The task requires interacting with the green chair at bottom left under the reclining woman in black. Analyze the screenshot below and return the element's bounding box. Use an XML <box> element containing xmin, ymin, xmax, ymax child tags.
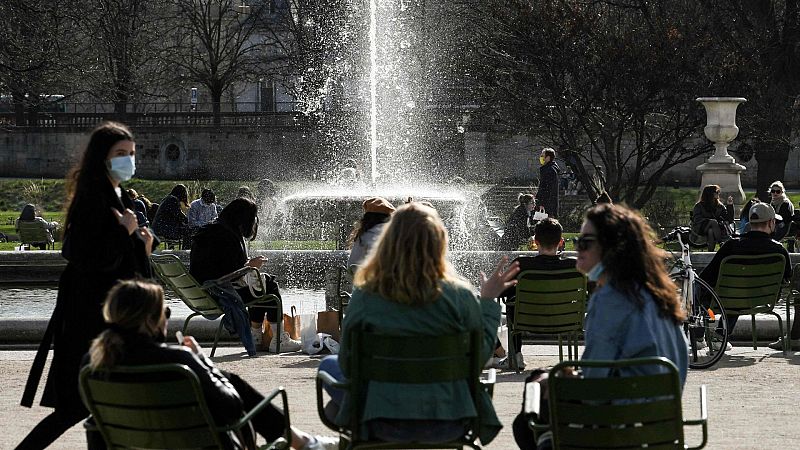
<box><xmin>80</xmin><ymin>364</ymin><xmax>291</xmax><ymax>449</ymax></box>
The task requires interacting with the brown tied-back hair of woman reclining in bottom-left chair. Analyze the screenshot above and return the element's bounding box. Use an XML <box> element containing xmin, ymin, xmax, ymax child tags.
<box><xmin>89</xmin><ymin>280</ymin><xmax>167</xmax><ymax>370</ymax></box>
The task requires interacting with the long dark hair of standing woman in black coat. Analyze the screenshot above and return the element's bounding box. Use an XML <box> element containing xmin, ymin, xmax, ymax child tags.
<box><xmin>64</xmin><ymin>122</ymin><xmax>133</xmax><ymax>230</ymax></box>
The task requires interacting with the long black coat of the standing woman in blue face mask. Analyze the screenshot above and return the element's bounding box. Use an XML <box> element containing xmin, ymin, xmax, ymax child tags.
<box><xmin>22</xmin><ymin>183</ymin><xmax>151</xmax><ymax>414</ymax></box>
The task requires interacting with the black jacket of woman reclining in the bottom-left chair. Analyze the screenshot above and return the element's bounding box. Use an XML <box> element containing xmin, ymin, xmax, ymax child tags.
<box><xmin>82</xmin><ymin>333</ymin><xmax>243</xmax><ymax>425</ymax></box>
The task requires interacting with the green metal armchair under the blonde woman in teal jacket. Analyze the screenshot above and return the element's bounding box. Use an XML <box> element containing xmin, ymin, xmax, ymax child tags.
<box><xmin>317</xmin><ymin>331</ymin><xmax>495</xmax><ymax>450</ymax></box>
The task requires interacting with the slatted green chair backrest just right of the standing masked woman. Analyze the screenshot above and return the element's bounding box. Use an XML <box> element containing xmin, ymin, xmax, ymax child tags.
<box><xmin>150</xmin><ymin>254</ymin><xmax>224</xmax><ymax>316</ymax></box>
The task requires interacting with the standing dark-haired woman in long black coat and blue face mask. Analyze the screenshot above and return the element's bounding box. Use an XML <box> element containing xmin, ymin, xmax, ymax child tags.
<box><xmin>18</xmin><ymin>122</ymin><xmax>153</xmax><ymax>449</ymax></box>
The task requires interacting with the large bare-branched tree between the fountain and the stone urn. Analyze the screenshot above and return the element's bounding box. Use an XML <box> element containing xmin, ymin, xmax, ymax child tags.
<box><xmin>479</xmin><ymin>0</ymin><xmax>728</xmax><ymax>208</ymax></box>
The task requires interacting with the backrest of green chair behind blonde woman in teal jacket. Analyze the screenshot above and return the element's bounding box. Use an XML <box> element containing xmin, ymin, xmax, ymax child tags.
<box><xmin>348</xmin><ymin>330</ymin><xmax>483</xmax><ymax>436</ymax></box>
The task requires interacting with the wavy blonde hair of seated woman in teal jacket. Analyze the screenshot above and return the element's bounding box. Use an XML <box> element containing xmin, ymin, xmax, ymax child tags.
<box><xmin>353</xmin><ymin>202</ymin><xmax>467</xmax><ymax>305</ymax></box>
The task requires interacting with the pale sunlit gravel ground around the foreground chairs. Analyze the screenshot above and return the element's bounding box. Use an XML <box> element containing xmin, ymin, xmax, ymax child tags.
<box><xmin>0</xmin><ymin>345</ymin><xmax>800</xmax><ymax>449</ymax></box>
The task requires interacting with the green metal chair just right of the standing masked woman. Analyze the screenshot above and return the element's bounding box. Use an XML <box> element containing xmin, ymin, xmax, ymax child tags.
<box><xmin>150</xmin><ymin>253</ymin><xmax>283</xmax><ymax>357</ymax></box>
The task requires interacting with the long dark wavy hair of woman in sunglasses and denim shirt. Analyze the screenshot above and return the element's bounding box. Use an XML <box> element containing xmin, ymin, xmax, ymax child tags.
<box><xmin>586</xmin><ymin>203</ymin><xmax>685</xmax><ymax>323</ymax></box>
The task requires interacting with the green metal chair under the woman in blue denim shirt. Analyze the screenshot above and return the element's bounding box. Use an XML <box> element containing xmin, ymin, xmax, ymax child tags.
<box><xmin>524</xmin><ymin>357</ymin><xmax>708</xmax><ymax>449</ymax></box>
